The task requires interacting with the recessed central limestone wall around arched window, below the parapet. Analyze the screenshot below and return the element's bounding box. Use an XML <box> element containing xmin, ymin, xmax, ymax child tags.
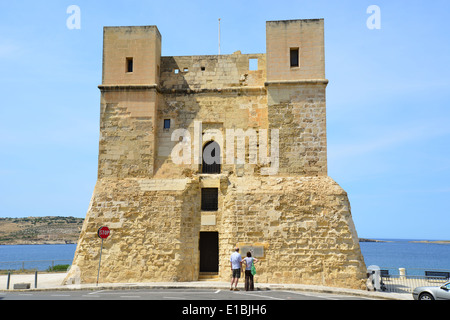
<box><xmin>155</xmin><ymin>89</ymin><xmax>268</xmax><ymax>178</ymax></box>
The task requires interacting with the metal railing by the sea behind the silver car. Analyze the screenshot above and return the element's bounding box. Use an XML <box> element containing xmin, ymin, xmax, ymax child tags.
<box><xmin>380</xmin><ymin>267</ymin><xmax>450</xmax><ymax>293</ymax></box>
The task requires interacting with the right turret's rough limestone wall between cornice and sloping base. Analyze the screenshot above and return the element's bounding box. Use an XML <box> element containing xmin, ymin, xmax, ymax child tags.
<box><xmin>267</xmin><ymin>82</ymin><xmax>327</xmax><ymax>176</ymax></box>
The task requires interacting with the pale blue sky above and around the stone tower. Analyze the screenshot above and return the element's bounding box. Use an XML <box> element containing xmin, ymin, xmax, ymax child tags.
<box><xmin>0</xmin><ymin>0</ymin><xmax>450</xmax><ymax>239</ymax></box>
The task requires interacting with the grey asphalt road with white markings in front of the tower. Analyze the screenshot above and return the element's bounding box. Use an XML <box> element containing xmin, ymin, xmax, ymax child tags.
<box><xmin>0</xmin><ymin>289</ymin><xmax>370</xmax><ymax>301</ymax></box>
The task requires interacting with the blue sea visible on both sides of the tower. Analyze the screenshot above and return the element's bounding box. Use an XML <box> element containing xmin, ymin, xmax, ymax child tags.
<box><xmin>0</xmin><ymin>239</ymin><xmax>450</xmax><ymax>275</ymax></box>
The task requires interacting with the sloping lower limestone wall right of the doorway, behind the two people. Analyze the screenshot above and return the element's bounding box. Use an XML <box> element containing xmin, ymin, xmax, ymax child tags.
<box><xmin>221</xmin><ymin>177</ymin><xmax>365</xmax><ymax>288</ymax></box>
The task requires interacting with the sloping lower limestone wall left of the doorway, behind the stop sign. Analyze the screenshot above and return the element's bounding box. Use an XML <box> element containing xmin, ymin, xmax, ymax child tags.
<box><xmin>68</xmin><ymin>179</ymin><xmax>200</xmax><ymax>283</ymax></box>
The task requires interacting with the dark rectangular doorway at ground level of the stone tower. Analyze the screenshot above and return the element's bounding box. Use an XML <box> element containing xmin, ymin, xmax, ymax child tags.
<box><xmin>199</xmin><ymin>232</ymin><xmax>219</xmax><ymax>272</ymax></box>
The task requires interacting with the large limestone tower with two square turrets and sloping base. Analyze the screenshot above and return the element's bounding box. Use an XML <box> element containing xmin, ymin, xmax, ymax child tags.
<box><xmin>66</xmin><ymin>19</ymin><xmax>365</xmax><ymax>288</ymax></box>
